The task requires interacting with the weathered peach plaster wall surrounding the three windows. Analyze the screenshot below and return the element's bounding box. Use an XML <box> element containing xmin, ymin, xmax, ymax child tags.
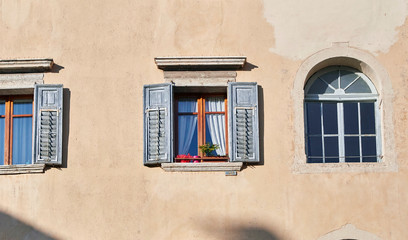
<box><xmin>0</xmin><ymin>0</ymin><xmax>408</xmax><ymax>240</ymax></box>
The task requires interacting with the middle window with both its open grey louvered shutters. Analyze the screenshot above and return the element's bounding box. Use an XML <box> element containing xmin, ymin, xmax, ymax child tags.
<box><xmin>144</xmin><ymin>82</ymin><xmax>259</xmax><ymax>165</ymax></box>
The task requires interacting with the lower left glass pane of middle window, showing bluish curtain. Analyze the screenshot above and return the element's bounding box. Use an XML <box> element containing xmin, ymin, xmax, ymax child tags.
<box><xmin>177</xmin><ymin>115</ymin><xmax>198</xmax><ymax>156</ymax></box>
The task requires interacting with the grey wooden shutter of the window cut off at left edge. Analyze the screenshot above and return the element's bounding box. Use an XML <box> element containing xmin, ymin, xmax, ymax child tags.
<box><xmin>33</xmin><ymin>84</ymin><xmax>63</xmax><ymax>165</ymax></box>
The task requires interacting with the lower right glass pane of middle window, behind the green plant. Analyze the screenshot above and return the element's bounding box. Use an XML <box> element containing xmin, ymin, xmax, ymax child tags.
<box><xmin>205</xmin><ymin>114</ymin><xmax>226</xmax><ymax>156</ymax></box>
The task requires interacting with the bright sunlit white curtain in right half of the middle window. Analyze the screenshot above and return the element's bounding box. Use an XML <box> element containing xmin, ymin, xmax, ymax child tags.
<box><xmin>205</xmin><ymin>97</ymin><xmax>226</xmax><ymax>156</ymax></box>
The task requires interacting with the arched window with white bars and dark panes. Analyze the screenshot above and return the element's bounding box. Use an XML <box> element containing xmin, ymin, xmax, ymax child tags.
<box><xmin>304</xmin><ymin>67</ymin><xmax>381</xmax><ymax>163</ymax></box>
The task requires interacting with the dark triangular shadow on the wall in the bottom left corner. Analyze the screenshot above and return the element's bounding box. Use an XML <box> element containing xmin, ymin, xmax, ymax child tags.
<box><xmin>0</xmin><ymin>212</ymin><xmax>56</xmax><ymax>240</ymax></box>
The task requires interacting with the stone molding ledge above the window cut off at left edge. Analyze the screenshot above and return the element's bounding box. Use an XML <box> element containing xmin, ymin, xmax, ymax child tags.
<box><xmin>0</xmin><ymin>59</ymin><xmax>54</xmax><ymax>73</ymax></box>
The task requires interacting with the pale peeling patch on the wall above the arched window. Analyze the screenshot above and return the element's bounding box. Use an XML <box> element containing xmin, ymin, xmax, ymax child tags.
<box><xmin>263</xmin><ymin>0</ymin><xmax>408</xmax><ymax>59</ymax></box>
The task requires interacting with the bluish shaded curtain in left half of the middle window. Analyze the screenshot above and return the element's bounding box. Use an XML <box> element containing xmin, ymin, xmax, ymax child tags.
<box><xmin>178</xmin><ymin>99</ymin><xmax>197</xmax><ymax>154</ymax></box>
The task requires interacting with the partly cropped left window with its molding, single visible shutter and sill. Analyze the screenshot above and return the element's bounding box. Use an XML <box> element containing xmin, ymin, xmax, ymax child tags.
<box><xmin>0</xmin><ymin>59</ymin><xmax>63</xmax><ymax>174</ymax></box>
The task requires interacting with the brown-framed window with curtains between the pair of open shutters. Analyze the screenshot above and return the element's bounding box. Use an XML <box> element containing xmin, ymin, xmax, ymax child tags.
<box><xmin>175</xmin><ymin>94</ymin><xmax>228</xmax><ymax>162</ymax></box>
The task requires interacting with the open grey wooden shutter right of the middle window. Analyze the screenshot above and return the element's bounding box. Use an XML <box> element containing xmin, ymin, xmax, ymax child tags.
<box><xmin>228</xmin><ymin>82</ymin><xmax>259</xmax><ymax>162</ymax></box>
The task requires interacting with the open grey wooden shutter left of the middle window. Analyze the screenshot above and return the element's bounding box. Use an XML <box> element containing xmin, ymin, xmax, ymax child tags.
<box><xmin>143</xmin><ymin>83</ymin><xmax>173</xmax><ymax>165</ymax></box>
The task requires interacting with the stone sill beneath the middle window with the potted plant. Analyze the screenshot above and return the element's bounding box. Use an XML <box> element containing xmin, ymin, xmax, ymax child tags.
<box><xmin>161</xmin><ymin>162</ymin><xmax>242</xmax><ymax>172</ymax></box>
